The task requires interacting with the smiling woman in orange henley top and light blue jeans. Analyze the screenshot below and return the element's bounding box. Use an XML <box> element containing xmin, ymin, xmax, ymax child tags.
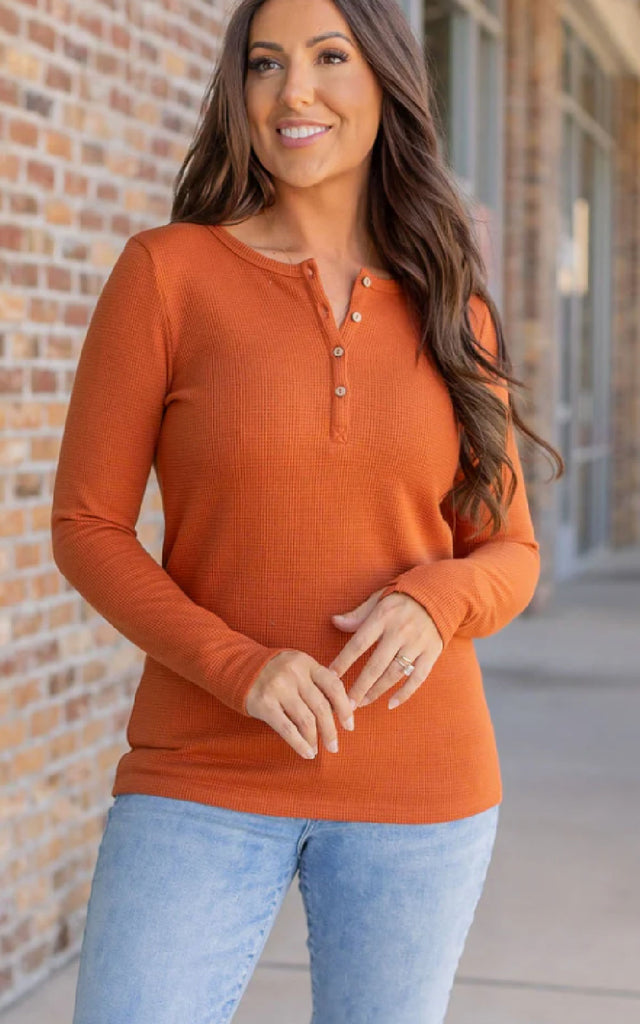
<box><xmin>52</xmin><ymin>0</ymin><xmax>561</xmax><ymax>1024</ymax></box>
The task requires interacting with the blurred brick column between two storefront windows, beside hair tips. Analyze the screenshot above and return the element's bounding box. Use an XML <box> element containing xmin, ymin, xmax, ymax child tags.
<box><xmin>503</xmin><ymin>0</ymin><xmax>561</xmax><ymax>613</ymax></box>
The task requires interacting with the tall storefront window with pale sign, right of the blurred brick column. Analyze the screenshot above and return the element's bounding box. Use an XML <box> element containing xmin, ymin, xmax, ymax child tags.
<box><xmin>557</xmin><ymin>24</ymin><xmax>612</xmax><ymax>574</ymax></box>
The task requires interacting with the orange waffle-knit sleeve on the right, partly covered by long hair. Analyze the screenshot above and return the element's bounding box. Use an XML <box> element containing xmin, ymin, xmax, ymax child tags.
<box><xmin>380</xmin><ymin>303</ymin><xmax>540</xmax><ymax>646</ymax></box>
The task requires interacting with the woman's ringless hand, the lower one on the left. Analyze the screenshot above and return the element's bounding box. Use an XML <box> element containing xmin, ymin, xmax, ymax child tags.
<box><xmin>245</xmin><ymin>650</ymin><xmax>353</xmax><ymax>758</ymax></box>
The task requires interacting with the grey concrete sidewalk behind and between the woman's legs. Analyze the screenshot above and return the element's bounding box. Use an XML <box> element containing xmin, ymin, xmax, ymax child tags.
<box><xmin>0</xmin><ymin>549</ymin><xmax>640</xmax><ymax>1024</ymax></box>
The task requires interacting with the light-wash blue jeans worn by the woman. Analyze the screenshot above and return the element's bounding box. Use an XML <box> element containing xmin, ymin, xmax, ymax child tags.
<box><xmin>73</xmin><ymin>793</ymin><xmax>500</xmax><ymax>1024</ymax></box>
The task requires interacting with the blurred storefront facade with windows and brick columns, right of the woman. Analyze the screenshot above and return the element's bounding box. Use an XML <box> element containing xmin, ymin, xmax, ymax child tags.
<box><xmin>403</xmin><ymin>0</ymin><xmax>640</xmax><ymax>593</ymax></box>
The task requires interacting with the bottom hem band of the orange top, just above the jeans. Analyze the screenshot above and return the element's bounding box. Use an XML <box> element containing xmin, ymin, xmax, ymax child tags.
<box><xmin>112</xmin><ymin>771</ymin><xmax>503</xmax><ymax>824</ymax></box>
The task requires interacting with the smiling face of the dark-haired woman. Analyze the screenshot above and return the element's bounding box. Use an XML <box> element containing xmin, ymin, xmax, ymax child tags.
<box><xmin>245</xmin><ymin>0</ymin><xmax>383</xmax><ymax>187</ymax></box>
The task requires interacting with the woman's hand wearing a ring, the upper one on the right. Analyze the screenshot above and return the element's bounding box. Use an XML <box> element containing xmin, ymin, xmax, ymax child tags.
<box><xmin>329</xmin><ymin>587</ymin><xmax>444</xmax><ymax>707</ymax></box>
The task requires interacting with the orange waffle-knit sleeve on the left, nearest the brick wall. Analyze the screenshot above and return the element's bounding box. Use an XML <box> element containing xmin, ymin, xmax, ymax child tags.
<box><xmin>51</xmin><ymin>238</ymin><xmax>288</xmax><ymax>715</ymax></box>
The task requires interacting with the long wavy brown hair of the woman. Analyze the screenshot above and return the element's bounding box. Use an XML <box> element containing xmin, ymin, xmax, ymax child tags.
<box><xmin>171</xmin><ymin>0</ymin><xmax>564</xmax><ymax>535</ymax></box>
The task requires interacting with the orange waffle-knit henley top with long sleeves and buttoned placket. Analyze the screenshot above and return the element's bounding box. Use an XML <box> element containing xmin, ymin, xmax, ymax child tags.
<box><xmin>51</xmin><ymin>222</ymin><xmax>540</xmax><ymax>823</ymax></box>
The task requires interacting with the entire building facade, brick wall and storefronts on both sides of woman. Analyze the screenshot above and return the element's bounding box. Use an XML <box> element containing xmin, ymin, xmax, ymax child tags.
<box><xmin>0</xmin><ymin>0</ymin><xmax>640</xmax><ymax>1011</ymax></box>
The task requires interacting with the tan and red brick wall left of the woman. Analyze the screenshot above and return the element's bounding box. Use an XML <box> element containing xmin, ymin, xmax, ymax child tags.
<box><xmin>0</xmin><ymin>0</ymin><xmax>225</xmax><ymax>1009</ymax></box>
